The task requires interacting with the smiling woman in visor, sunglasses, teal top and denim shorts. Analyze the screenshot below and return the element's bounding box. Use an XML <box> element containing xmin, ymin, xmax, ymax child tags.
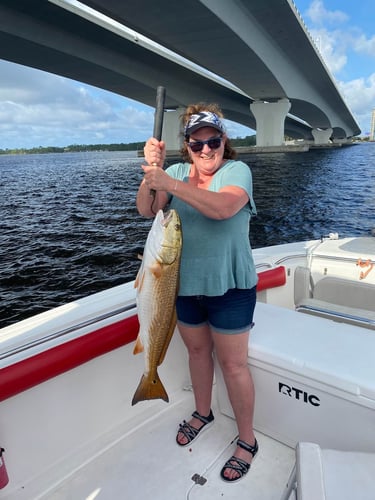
<box><xmin>137</xmin><ymin>104</ymin><xmax>258</xmax><ymax>482</ymax></box>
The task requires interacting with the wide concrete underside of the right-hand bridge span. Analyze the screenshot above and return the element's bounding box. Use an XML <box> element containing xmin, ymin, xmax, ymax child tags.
<box><xmin>85</xmin><ymin>0</ymin><xmax>360</xmax><ymax>138</ymax></box>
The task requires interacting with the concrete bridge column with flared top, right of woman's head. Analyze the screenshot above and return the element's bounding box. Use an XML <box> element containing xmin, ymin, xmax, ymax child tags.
<box><xmin>250</xmin><ymin>99</ymin><xmax>290</xmax><ymax>147</ymax></box>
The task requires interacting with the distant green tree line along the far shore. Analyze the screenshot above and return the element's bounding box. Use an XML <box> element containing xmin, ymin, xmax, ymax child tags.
<box><xmin>0</xmin><ymin>135</ymin><xmax>256</xmax><ymax>155</ymax></box>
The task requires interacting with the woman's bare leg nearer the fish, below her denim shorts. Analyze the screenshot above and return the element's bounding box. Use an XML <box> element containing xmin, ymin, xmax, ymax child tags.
<box><xmin>177</xmin><ymin>324</ymin><xmax>214</xmax><ymax>445</ymax></box>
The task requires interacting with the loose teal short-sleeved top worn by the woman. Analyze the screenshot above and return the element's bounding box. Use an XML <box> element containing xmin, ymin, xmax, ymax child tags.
<box><xmin>166</xmin><ymin>160</ymin><xmax>258</xmax><ymax>296</ymax></box>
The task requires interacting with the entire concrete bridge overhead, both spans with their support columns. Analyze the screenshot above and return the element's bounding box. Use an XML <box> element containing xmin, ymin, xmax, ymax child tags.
<box><xmin>0</xmin><ymin>0</ymin><xmax>360</xmax><ymax>148</ymax></box>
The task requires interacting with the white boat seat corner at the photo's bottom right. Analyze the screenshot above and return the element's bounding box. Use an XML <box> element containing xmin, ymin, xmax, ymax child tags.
<box><xmin>296</xmin><ymin>442</ymin><xmax>375</xmax><ymax>500</ymax></box>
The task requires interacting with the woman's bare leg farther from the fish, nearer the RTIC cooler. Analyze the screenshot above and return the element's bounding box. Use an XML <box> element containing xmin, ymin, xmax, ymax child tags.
<box><xmin>213</xmin><ymin>331</ymin><xmax>255</xmax><ymax>479</ymax></box>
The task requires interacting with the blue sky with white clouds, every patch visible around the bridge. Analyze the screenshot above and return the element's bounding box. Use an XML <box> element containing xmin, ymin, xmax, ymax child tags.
<box><xmin>0</xmin><ymin>0</ymin><xmax>375</xmax><ymax>149</ymax></box>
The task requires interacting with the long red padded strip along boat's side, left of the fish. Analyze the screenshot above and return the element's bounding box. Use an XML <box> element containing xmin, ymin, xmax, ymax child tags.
<box><xmin>0</xmin><ymin>315</ymin><xmax>139</xmax><ymax>401</ymax></box>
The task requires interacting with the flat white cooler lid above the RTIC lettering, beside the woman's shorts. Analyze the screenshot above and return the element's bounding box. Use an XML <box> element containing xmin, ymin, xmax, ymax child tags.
<box><xmin>248</xmin><ymin>302</ymin><xmax>375</xmax><ymax>401</ymax></box>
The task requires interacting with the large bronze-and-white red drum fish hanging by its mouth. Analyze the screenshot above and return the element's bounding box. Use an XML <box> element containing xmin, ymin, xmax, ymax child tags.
<box><xmin>132</xmin><ymin>210</ymin><xmax>182</xmax><ymax>405</ymax></box>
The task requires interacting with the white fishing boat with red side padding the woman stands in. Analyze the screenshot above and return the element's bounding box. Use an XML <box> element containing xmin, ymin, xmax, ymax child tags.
<box><xmin>0</xmin><ymin>238</ymin><xmax>375</xmax><ymax>500</ymax></box>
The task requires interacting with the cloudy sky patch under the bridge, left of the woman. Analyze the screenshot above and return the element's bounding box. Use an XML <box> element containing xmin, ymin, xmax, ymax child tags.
<box><xmin>0</xmin><ymin>61</ymin><xmax>153</xmax><ymax>149</ymax></box>
